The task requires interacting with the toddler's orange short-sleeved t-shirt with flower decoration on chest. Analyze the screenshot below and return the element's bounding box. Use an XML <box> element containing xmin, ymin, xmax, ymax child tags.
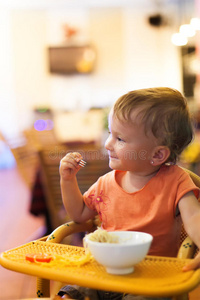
<box><xmin>84</xmin><ymin>165</ymin><xmax>199</xmax><ymax>256</ymax></box>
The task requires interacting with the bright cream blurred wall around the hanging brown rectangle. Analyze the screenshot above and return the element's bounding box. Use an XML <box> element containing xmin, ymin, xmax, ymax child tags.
<box><xmin>0</xmin><ymin>7</ymin><xmax>182</xmax><ymax>137</ymax></box>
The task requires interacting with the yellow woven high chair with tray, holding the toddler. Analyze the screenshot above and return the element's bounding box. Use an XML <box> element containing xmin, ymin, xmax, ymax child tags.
<box><xmin>0</xmin><ymin>170</ymin><xmax>200</xmax><ymax>300</ymax></box>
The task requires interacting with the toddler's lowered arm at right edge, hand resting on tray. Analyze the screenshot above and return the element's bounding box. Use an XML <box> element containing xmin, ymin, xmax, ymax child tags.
<box><xmin>179</xmin><ymin>192</ymin><xmax>200</xmax><ymax>271</ymax></box>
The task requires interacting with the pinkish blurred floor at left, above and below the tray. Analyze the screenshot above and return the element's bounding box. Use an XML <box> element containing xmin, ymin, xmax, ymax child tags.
<box><xmin>0</xmin><ymin>168</ymin><xmax>200</xmax><ymax>300</ymax></box>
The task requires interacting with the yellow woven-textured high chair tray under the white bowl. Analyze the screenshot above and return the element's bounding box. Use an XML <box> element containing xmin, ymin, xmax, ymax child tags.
<box><xmin>0</xmin><ymin>241</ymin><xmax>200</xmax><ymax>296</ymax></box>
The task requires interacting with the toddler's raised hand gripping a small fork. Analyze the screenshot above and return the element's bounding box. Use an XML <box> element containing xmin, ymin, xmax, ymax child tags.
<box><xmin>60</xmin><ymin>152</ymin><xmax>82</xmax><ymax>180</ymax></box>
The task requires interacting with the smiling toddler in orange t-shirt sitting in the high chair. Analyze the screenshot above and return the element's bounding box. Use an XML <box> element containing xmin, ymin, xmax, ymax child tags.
<box><xmin>55</xmin><ymin>87</ymin><xmax>200</xmax><ymax>300</ymax></box>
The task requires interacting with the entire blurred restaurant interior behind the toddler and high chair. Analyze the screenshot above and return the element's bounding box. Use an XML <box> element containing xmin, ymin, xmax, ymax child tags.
<box><xmin>0</xmin><ymin>0</ymin><xmax>200</xmax><ymax>300</ymax></box>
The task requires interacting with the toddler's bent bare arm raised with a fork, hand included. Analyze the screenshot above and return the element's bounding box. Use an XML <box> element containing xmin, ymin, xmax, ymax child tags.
<box><xmin>60</xmin><ymin>152</ymin><xmax>95</xmax><ymax>223</ymax></box>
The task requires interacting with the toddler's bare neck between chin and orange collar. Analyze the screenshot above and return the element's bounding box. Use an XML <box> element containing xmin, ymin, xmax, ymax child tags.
<box><xmin>119</xmin><ymin>169</ymin><xmax>159</xmax><ymax>193</ymax></box>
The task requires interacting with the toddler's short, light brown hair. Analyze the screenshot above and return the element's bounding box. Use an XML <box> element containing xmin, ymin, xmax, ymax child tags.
<box><xmin>113</xmin><ymin>87</ymin><xmax>193</xmax><ymax>163</ymax></box>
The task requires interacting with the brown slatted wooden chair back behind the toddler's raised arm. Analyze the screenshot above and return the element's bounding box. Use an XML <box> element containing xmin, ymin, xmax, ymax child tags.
<box><xmin>39</xmin><ymin>145</ymin><xmax>110</xmax><ymax>229</ymax></box>
